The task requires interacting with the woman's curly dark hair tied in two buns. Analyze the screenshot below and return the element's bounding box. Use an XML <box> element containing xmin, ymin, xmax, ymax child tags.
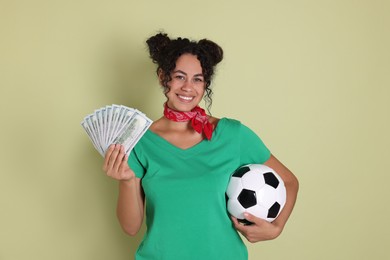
<box><xmin>146</xmin><ymin>32</ymin><xmax>223</xmax><ymax>112</ymax></box>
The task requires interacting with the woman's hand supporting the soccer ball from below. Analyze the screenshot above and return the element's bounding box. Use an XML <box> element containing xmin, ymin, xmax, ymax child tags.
<box><xmin>231</xmin><ymin>213</ymin><xmax>282</xmax><ymax>243</ymax></box>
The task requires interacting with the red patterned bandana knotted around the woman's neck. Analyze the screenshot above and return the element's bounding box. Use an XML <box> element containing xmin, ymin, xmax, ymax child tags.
<box><xmin>164</xmin><ymin>103</ymin><xmax>214</xmax><ymax>140</ymax></box>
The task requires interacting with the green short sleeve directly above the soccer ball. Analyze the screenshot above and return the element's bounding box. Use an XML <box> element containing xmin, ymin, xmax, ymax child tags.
<box><xmin>239</xmin><ymin>124</ymin><xmax>271</xmax><ymax>165</ymax></box>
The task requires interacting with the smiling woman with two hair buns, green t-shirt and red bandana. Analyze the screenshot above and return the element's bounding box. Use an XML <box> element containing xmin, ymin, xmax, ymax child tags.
<box><xmin>103</xmin><ymin>33</ymin><xmax>298</xmax><ymax>260</ymax></box>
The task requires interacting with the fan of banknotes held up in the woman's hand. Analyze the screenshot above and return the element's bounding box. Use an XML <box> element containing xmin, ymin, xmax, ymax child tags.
<box><xmin>81</xmin><ymin>104</ymin><xmax>152</xmax><ymax>157</ymax></box>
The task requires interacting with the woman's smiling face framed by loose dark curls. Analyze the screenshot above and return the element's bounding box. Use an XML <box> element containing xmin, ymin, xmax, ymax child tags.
<box><xmin>162</xmin><ymin>54</ymin><xmax>205</xmax><ymax>111</ymax></box>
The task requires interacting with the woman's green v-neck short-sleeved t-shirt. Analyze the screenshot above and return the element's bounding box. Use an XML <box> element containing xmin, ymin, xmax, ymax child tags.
<box><xmin>129</xmin><ymin>118</ymin><xmax>270</xmax><ymax>260</ymax></box>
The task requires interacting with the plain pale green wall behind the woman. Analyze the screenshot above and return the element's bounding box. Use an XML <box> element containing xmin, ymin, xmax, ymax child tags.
<box><xmin>0</xmin><ymin>0</ymin><xmax>390</xmax><ymax>260</ymax></box>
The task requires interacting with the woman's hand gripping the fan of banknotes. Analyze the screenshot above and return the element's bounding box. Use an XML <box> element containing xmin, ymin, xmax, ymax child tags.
<box><xmin>103</xmin><ymin>144</ymin><xmax>135</xmax><ymax>181</ymax></box>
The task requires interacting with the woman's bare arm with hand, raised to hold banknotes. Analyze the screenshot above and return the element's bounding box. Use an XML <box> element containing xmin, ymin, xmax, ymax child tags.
<box><xmin>103</xmin><ymin>145</ymin><xmax>144</xmax><ymax>236</ymax></box>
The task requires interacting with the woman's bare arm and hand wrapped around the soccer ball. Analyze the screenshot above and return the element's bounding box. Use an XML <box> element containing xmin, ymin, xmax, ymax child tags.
<box><xmin>232</xmin><ymin>155</ymin><xmax>299</xmax><ymax>243</ymax></box>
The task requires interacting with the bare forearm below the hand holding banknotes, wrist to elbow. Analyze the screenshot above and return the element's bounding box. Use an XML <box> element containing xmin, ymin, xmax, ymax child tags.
<box><xmin>117</xmin><ymin>177</ymin><xmax>144</xmax><ymax>236</ymax></box>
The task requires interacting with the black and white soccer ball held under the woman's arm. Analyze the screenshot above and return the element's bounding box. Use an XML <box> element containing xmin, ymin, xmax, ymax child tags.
<box><xmin>226</xmin><ymin>164</ymin><xmax>286</xmax><ymax>225</ymax></box>
